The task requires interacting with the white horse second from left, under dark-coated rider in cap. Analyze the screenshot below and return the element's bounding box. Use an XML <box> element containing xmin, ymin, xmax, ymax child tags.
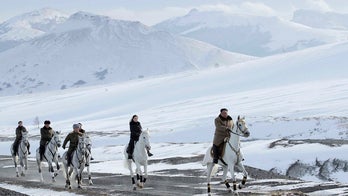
<box><xmin>36</xmin><ymin>131</ymin><xmax>62</xmax><ymax>182</ymax></box>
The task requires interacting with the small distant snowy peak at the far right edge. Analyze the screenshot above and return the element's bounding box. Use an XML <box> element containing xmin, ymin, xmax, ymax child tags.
<box><xmin>292</xmin><ymin>10</ymin><xmax>348</xmax><ymax>30</ymax></box>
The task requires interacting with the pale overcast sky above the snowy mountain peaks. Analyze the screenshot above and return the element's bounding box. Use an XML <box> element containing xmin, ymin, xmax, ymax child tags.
<box><xmin>0</xmin><ymin>0</ymin><xmax>348</xmax><ymax>25</ymax></box>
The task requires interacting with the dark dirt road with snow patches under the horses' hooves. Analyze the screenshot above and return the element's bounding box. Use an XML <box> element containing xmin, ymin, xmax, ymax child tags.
<box><xmin>0</xmin><ymin>156</ymin><xmax>348</xmax><ymax>196</ymax></box>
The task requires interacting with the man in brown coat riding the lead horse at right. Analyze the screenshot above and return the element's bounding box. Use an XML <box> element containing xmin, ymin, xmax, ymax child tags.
<box><xmin>213</xmin><ymin>108</ymin><xmax>233</xmax><ymax>164</ymax></box>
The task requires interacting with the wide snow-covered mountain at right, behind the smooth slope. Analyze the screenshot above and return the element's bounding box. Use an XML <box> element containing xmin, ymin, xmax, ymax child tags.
<box><xmin>154</xmin><ymin>9</ymin><xmax>348</xmax><ymax>56</ymax></box>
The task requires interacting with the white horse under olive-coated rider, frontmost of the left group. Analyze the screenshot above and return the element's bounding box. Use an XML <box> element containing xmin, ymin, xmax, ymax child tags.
<box><xmin>63</xmin><ymin>135</ymin><xmax>86</xmax><ymax>189</ymax></box>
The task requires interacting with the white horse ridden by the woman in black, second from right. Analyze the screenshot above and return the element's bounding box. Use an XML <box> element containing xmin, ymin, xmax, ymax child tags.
<box><xmin>124</xmin><ymin>130</ymin><xmax>151</xmax><ymax>190</ymax></box>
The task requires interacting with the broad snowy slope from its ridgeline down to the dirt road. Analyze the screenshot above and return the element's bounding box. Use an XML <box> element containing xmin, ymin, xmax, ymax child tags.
<box><xmin>0</xmin><ymin>42</ymin><xmax>348</xmax><ymax>185</ymax></box>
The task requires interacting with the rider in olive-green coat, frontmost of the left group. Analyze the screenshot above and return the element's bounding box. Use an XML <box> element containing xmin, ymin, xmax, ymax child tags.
<box><xmin>63</xmin><ymin>124</ymin><xmax>83</xmax><ymax>166</ymax></box>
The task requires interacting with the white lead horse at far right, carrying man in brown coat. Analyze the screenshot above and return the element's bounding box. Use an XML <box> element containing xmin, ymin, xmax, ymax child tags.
<box><xmin>203</xmin><ymin>116</ymin><xmax>250</xmax><ymax>195</ymax></box>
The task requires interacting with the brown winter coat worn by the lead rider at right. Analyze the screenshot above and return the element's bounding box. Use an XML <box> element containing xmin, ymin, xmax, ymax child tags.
<box><xmin>213</xmin><ymin>115</ymin><xmax>233</xmax><ymax>146</ymax></box>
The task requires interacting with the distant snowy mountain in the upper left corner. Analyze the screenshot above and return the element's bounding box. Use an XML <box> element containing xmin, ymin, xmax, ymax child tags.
<box><xmin>0</xmin><ymin>8</ymin><xmax>68</xmax><ymax>52</ymax></box>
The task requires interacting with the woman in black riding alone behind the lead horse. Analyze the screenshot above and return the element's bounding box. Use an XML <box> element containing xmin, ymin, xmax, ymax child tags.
<box><xmin>127</xmin><ymin>115</ymin><xmax>153</xmax><ymax>159</ymax></box>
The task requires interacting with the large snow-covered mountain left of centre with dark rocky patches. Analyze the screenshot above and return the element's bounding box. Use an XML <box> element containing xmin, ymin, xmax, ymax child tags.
<box><xmin>0</xmin><ymin>12</ymin><xmax>254</xmax><ymax>95</ymax></box>
